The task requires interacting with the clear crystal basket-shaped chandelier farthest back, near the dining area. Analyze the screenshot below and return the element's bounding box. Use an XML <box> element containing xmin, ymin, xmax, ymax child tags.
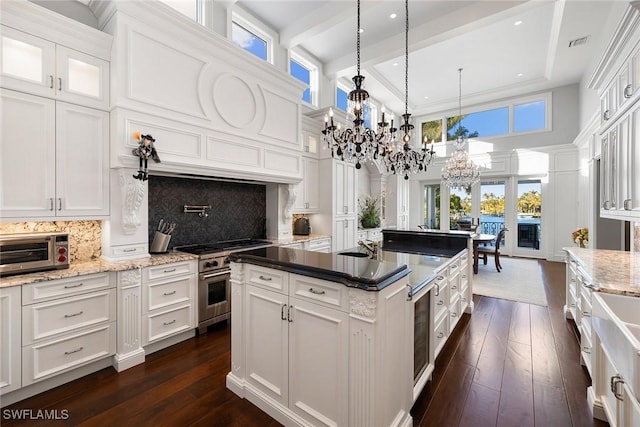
<box><xmin>442</xmin><ymin>68</ymin><xmax>480</xmax><ymax>188</ymax></box>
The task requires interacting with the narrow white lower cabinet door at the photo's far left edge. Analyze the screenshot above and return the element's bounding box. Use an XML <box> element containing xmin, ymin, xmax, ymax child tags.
<box><xmin>0</xmin><ymin>286</ymin><xmax>22</xmax><ymax>395</ymax></box>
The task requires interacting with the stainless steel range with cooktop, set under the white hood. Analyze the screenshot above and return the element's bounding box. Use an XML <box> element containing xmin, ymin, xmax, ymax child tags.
<box><xmin>174</xmin><ymin>239</ymin><xmax>272</xmax><ymax>334</ymax></box>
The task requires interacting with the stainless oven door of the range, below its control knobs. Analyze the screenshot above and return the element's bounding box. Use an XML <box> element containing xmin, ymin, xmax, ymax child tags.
<box><xmin>198</xmin><ymin>269</ymin><xmax>231</xmax><ymax>332</ymax></box>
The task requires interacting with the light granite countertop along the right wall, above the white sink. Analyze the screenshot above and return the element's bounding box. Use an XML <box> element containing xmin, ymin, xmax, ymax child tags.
<box><xmin>563</xmin><ymin>247</ymin><xmax>640</xmax><ymax>297</ymax></box>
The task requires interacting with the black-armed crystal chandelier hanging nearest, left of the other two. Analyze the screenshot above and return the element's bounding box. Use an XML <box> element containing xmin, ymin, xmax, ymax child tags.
<box><xmin>322</xmin><ymin>0</ymin><xmax>396</xmax><ymax>169</ymax></box>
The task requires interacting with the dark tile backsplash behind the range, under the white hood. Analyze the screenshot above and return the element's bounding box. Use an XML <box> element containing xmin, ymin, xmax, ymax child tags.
<box><xmin>149</xmin><ymin>176</ymin><xmax>266</xmax><ymax>248</ymax></box>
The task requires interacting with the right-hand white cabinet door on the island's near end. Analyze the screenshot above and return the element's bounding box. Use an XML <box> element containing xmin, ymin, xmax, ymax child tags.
<box><xmin>289</xmin><ymin>298</ymin><xmax>349</xmax><ymax>426</ymax></box>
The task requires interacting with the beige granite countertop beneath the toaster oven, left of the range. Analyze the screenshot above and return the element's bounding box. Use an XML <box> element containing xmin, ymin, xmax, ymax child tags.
<box><xmin>0</xmin><ymin>252</ymin><xmax>198</xmax><ymax>288</ymax></box>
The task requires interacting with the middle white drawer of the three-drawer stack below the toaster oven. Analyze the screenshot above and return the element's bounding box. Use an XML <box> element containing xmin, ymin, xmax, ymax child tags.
<box><xmin>22</xmin><ymin>289</ymin><xmax>116</xmax><ymax>345</ymax></box>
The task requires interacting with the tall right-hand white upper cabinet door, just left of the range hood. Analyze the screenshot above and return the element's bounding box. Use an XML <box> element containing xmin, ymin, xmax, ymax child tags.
<box><xmin>56</xmin><ymin>102</ymin><xmax>109</xmax><ymax>216</ymax></box>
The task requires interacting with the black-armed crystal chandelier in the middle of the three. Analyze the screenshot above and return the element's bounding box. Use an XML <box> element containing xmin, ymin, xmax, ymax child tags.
<box><xmin>381</xmin><ymin>0</ymin><xmax>434</xmax><ymax>179</ymax></box>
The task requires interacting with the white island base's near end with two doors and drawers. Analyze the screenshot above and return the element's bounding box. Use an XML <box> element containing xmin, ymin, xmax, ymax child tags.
<box><xmin>227</xmin><ymin>262</ymin><xmax>413</xmax><ymax>426</ymax></box>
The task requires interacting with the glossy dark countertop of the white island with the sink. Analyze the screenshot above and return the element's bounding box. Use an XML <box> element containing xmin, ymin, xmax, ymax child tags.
<box><xmin>229</xmin><ymin>247</ymin><xmax>456</xmax><ymax>293</ymax></box>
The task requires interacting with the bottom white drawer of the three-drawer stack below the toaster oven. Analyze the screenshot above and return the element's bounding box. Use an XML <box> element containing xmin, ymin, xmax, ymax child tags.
<box><xmin>22</xmin><ymin>323</ymin><xmax>116</xmax><ymax>386</ymax></box>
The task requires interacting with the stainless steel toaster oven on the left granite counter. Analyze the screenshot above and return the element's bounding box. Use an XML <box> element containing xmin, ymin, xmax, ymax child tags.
<box><xmin>0</xmin><ymin>233</ymin><xmax>69</xmax><ymax>276</ymax></box>
